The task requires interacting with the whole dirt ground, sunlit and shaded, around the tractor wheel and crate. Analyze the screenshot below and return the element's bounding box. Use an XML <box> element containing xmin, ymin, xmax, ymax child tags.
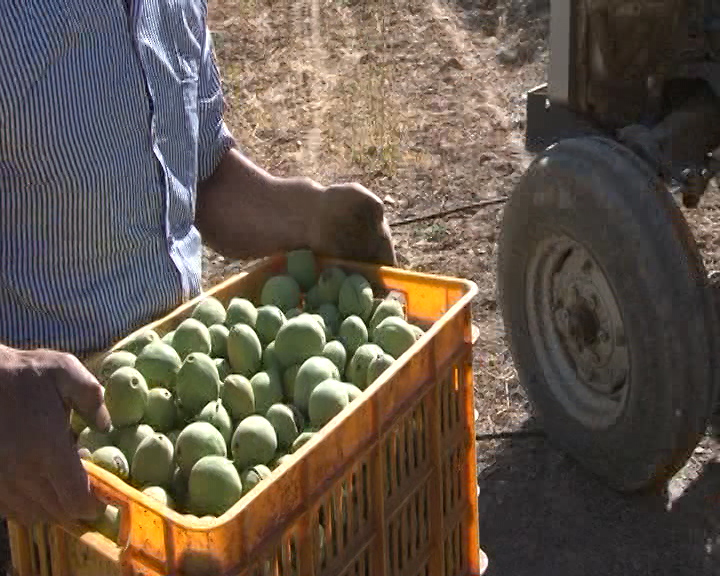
<box><xmin>205</xmin><ymin>0</ymin><xmax>720</xmax><ymax>576</ymax></box>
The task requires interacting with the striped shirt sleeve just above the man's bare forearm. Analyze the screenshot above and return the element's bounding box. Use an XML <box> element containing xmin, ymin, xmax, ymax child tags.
<box><xmin>198</xmin><ymin>27</ymin><xmax>235</xmax><ymax>182</ymax></box>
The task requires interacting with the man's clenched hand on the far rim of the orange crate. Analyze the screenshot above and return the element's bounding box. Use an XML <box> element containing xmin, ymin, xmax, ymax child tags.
<box><xmin>308</xmin><ymin>183</ymin><xmax>397</xmax><ymax>266</ymax></box>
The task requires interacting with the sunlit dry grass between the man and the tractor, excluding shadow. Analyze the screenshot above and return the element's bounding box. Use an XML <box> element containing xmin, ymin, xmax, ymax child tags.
<box><xmin>200</xmin><ymin>0</ymin><xmax>544</xmax><ymax>432</ymax></box>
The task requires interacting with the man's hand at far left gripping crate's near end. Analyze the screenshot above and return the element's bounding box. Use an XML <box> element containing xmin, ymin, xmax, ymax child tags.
<box><xmin>0</xmin><ymin>346</ymin><xmax>110</xmax><ymax>524</ymax></box>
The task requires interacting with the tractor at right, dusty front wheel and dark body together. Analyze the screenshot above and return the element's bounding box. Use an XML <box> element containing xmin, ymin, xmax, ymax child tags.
<box><xmin>497</xmin><ymin>0</ymin><xmax>720</xmax><ymax>493</ymax></box>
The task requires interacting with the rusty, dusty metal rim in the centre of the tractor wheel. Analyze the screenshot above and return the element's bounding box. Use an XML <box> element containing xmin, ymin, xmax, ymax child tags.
<box><xmin>526</xmin><ymin>237</ymin><xmax>630</xmax><ymax>428</ymax></box>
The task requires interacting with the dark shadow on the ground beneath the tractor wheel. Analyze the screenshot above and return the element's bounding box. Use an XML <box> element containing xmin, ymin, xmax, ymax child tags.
<box><xmin>478</xmin><ymin>418</ymin><xmax>720</xmax><ymax>576</ymax></box>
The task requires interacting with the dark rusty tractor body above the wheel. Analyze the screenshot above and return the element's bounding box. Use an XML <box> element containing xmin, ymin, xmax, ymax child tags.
<box><xmin>526</xmin><ymin>0</ymin><xmax>720</xmax><ymax>206</ymax></box>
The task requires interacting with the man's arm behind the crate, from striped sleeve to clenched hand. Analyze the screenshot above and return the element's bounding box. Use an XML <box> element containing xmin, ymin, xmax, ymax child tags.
<box><xmin>195</xmin><ymin>31</ymin><xmax>396</xmax><ymax>265</ymax></box>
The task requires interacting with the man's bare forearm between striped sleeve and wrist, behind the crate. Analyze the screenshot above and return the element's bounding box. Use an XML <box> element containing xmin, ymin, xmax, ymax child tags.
<box><xmin>195</xmin><ymin>149</ymin><xmax>322</xmax><ymax>259</ymax></box>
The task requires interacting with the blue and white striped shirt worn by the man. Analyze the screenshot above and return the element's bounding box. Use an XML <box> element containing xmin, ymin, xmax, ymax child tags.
<box><xmin>0</xmin><ymin>0</ymin><xmax>234</xmax><ymax>355</ymax></box>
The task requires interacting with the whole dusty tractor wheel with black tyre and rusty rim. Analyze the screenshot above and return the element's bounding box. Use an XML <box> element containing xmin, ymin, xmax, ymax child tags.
<box><xmin>498</xmin><ymin>137</ymin><xmax>716</xmax><ymax>492</ymax></box>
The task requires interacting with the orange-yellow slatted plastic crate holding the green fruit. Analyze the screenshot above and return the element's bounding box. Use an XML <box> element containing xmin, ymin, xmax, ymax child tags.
<box><xmin>9</xmin><ymin>256</ymin><xmax>487</xmax><ymax>576</ymax></box>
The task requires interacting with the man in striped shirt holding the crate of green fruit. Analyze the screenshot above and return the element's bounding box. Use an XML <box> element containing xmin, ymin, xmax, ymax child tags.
<box><xmin>0</xmin><ymin>0</ymin><xmax>395</xmax><ymax>544</ymax></box>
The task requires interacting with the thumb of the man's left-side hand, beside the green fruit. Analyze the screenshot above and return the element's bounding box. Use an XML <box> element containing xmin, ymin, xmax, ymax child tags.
<box><xmin>57</xmin><ymin>355</ymin><xmax>111</xmax><ymax>432</ymax></box>
